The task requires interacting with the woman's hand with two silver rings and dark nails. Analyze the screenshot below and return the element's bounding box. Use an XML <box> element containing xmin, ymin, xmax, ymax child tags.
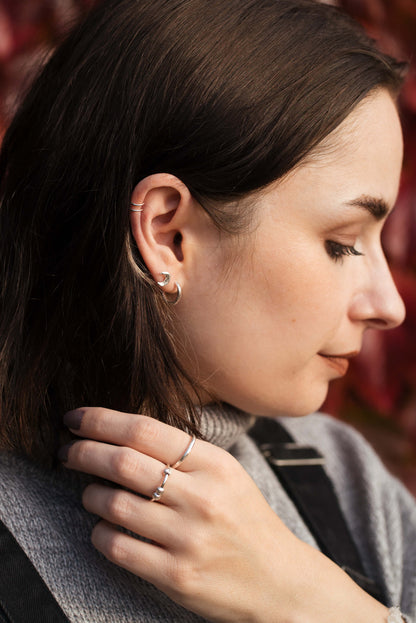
<box><xmin>60</xmin><ymin>408</ymin><xmax>387</xmax><ymax>623</ymax></box>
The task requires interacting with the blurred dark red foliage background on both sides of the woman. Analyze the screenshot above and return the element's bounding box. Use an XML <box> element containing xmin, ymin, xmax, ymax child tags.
<box><xmin>0</xmin><ymin>0</ymin><xmax>416</xmax><ymax>493</ymax></box>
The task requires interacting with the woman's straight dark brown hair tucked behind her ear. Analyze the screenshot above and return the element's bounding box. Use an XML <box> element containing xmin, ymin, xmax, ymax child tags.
<box><xmin>0</xmin><ymin>0</ymin><xmax>402</xmax><ymax>460</ymax></box>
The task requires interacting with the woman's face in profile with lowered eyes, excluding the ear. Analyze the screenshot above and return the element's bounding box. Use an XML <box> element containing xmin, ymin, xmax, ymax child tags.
<box><xmin>177</xmin><ymin>91</ymin><xmax>405</xmax><ymax>415</ymax></box>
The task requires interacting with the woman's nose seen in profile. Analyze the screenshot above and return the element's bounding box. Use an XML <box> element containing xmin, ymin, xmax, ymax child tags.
<box><xmin>350</xmin><ymin>256</ymin><xmax>406</xmax><ymax>330</ymax></box>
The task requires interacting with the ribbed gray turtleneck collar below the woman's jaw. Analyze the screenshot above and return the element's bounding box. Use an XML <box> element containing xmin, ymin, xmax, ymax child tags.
<box><xmin>200</xmin><ymin>403</ymin><xmax>255</xmax><ymax>450</ymax></box>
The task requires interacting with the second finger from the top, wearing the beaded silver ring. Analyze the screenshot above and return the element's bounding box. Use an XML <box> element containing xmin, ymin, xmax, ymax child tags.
<box><xmin>61</xmin><ymin>439</ymin><xmax>188</xmax><ymax>506</ymax></box>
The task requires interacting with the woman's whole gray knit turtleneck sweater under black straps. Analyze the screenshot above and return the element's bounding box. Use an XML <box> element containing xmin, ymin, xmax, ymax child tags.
<box><xmin>0</xmin><ymin>407</ymin><xmax>416</xmax><ymax>623</ymax></box>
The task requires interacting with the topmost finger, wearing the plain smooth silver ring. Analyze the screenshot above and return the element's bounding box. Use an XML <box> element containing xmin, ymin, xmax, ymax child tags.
<box><xmin>64</xmin><ymin>407</ymin><xmax>206</xmax><ymax>471</ymax></box>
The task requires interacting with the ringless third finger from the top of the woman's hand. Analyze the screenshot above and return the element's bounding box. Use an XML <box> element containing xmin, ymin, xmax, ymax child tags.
<box><xmin>82</xmin><ymin>484</ymin><xmax>180</xmax><ymax>547</ymax></box>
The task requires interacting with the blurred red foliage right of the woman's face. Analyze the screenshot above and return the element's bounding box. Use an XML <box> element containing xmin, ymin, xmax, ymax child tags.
<box><xmin>325</xmin><ymin>0</ymin><xmax>416</xmax><ymax>494</ymax></box>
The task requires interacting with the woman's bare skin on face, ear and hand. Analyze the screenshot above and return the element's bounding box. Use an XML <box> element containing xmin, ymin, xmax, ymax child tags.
<box><xmin>62</xmin><ymin>91</ymin><xmax>404</xmax><ymax>623</ymax></box>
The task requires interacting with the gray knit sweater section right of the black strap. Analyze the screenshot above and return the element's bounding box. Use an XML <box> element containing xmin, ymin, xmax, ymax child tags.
<box><xmin>283</xmin><ymin>414</ymin><xmax>416</xmax><ymax>623</ymax></box>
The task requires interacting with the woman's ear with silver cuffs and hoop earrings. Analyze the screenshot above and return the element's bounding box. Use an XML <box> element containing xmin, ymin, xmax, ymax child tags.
<box><xmin>130</xmin><ymin>173</ymin><xmax>210</xmax><ymax>300</ymax></box>
